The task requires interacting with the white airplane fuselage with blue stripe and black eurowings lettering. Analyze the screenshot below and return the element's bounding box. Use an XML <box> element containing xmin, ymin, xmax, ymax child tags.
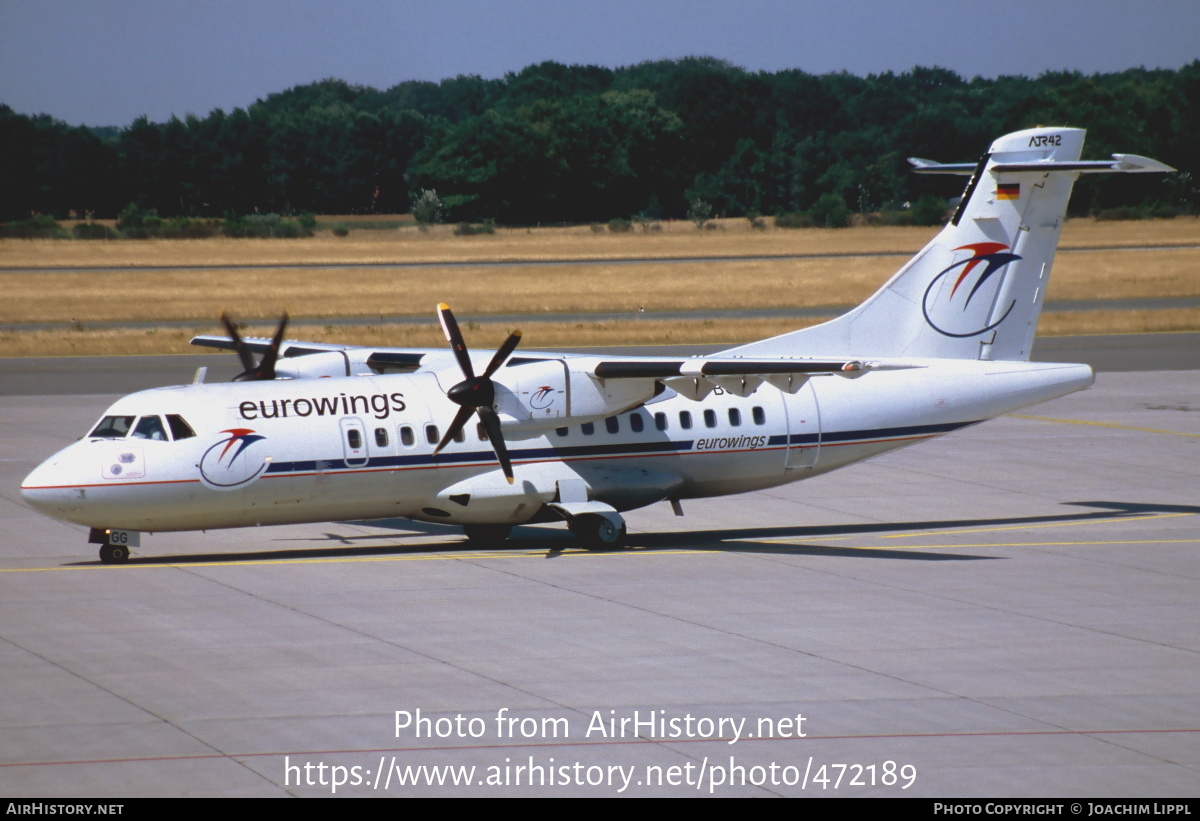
<box><xmin>22</xmin><ymin>360</ymin><xmax>1092</xmax><ymax>531</ymax></box>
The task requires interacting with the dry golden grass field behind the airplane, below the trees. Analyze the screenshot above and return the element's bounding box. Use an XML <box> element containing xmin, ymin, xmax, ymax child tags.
<box><xmin>0</xmin><ymin>218</ymin><xmax>1200</xmax><ymax>355</ymax></box>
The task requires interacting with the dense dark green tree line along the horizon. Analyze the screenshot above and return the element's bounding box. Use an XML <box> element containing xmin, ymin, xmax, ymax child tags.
<box><xmin>0</xmin><ymin>58</ymin><xmax>1200</xmax><ymax>224</ymax></box>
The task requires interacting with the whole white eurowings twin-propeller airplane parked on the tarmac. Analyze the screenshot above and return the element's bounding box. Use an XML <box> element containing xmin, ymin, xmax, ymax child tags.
<box><xmin>22</xmin><ymin>127</ymin><xmax>1172</xmax><ymax>563</ymax></box>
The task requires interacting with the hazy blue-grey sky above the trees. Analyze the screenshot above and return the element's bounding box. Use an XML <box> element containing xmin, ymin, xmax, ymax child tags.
<box><xmin>0</xmin><ymin>0</ymin><xmax>1200</xmax><ymax>125</ymax></box>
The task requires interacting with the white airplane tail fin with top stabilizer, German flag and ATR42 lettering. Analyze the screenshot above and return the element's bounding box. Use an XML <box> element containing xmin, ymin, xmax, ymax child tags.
<box><xmin>722</xmin><ymin>127</ymin><xmax>1174</xmax><ymax>360</ymax></box>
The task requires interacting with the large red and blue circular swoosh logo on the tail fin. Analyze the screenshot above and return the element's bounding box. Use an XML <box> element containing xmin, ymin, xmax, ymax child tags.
<box><xmin>922</xmin><ymin>242</ymin><xmax>1021</xmax><ymax>338</ymax></box>
